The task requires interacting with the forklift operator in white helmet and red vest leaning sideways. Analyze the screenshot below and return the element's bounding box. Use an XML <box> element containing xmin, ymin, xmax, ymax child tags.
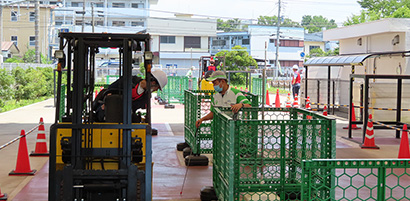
<box><xmin>94</xmin><ymin>70</ymin><xmax>168</xmax><ymax>122</ymax></box>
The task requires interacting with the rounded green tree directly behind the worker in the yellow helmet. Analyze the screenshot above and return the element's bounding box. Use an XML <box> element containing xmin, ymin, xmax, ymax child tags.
<box><xmin>215</xmin><ymin>45</ymin><xmax>258</xmax><ymax>84</ymax></box>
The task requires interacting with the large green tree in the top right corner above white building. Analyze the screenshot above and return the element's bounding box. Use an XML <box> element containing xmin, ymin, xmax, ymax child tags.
<box><xmin>343</xmin><ymin>0</ymin><xmax>410</xmax><ymax>26</ymax></box>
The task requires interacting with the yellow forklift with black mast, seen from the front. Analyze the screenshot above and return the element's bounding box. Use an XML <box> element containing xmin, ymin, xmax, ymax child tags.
<box><xmin>48</xmin><ymin>33</ymin><xmax>152</xmax><ymax>201</ymax></box>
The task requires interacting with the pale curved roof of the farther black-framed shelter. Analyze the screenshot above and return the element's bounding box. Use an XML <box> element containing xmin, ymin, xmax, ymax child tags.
<box><xmin>303</xmin><ymin>54</ymin><xmax>372</xmax><ymax>66</ymax></box>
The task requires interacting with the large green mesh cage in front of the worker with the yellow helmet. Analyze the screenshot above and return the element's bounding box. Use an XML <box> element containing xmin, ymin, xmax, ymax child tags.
<box><xmin>212</xmin><ymin>108</ymin><xmax>336</xmax><ymax>201</ymax></box>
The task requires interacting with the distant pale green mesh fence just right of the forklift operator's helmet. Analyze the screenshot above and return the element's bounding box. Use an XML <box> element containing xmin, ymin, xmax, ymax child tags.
<box><xmin>158</xmin><ymin>76</ymin><xmax>197</xmax><ymax>103</ymax></box>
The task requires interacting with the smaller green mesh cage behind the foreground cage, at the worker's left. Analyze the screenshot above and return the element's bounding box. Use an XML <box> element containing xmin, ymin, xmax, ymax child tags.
<box><xmin>184</xmin><ymin>90</ymin><xmax>258</xmax><ymax>154</ymax></box>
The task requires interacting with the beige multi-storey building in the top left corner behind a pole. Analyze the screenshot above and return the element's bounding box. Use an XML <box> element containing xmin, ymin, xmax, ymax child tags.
<box><xmin>1</xmin><ymin>4</ymin><xmax>53</xmax><ymax>59</ymax></box>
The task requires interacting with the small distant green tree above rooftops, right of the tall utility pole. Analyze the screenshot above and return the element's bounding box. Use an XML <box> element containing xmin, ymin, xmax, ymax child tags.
<box><xmin>301</xmin><ymin>15</ymin><xmax>337</xmax><ymax>33</ymax></box>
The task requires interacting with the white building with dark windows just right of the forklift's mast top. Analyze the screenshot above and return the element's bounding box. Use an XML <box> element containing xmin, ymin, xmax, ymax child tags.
<box><xmin>147</xmin><ymin>15</ymin><xmax>216</xmax><ymax>73</ymax></box>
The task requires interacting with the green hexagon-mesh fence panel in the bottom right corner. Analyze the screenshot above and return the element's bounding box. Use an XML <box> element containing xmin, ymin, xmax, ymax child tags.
<box><xmin>302</xmin><ymin>159</ymin><xmax>410</xmax><ymax>201</ymax></box>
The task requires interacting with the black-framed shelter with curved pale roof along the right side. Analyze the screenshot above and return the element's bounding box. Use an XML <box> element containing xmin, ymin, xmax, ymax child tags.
<box><xmin>304</xmin><ymin>51</ymin><xmax>410</xmax><ymax>139</ymax></box>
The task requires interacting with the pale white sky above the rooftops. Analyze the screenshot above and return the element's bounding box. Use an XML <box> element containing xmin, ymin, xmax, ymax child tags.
<box><xmin>150</xmin><ymin>0</ymin><xmax>361</xmax><ymax>26</ymax></box>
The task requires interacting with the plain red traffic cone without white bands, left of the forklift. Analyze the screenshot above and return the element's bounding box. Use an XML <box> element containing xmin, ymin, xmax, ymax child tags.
<box><xmin>9</xmin><ymin>130</ymin><xmax>36</xmax><ymax>175</ymax></box>
